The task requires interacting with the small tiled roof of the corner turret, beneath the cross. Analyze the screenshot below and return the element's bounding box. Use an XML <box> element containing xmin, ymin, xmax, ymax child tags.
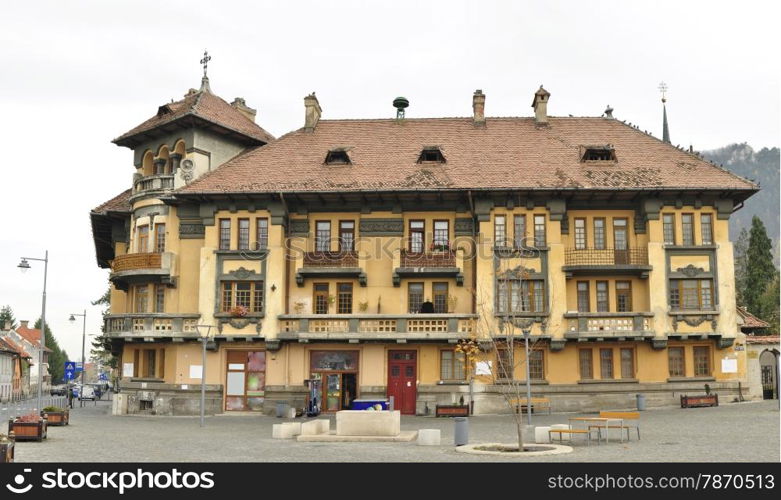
<box><xmin>113</xmin><ymin>86</ymin><xmax>274</xmax><ymax>145</ymax></box>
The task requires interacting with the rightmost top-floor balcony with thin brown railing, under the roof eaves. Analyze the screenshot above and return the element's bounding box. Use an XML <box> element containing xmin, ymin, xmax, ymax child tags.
<box><xmin>562</xmin><ymin>248</ymin><xmax>653</xmax><ymax>278</ymax></box>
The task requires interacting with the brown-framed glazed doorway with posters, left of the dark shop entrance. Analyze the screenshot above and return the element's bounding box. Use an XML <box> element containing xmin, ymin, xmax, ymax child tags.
<box><xmin>225</xmin><ymin>351</ymin><xmax>266</xmax><ymax>411</ymax></box>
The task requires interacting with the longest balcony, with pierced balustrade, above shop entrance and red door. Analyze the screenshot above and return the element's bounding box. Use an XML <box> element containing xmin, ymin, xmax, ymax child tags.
<box><xmin>279</xmin><ymin>314</ymin><xmax>476</xmax><ymax>343</ymax></box>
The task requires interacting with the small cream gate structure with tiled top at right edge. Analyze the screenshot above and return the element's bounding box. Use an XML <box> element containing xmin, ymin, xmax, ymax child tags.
<box><xmin>738</xmin><ymin>307</ymin><xmax>781</xmax><ymax>399</ymax></box>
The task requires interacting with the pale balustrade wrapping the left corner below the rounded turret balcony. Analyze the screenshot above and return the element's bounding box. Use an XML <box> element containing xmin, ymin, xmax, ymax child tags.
<box><xmin>104</xmin><ymin>313</ymin><xmax>201</xmax><ymax>337</ymax></box>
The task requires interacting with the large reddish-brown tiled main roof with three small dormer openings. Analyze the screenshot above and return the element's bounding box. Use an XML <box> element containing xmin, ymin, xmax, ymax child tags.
<box><xmin>178</xmin><ymin>117</ymin><xmax>758</xmax><ymax>194</ymax></box>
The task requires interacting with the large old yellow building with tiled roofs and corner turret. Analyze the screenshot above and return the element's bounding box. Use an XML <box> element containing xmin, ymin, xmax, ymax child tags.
<box><xmin>91</xmin><ymin>78</ymin><xmax>758</xmax><ymax>414</ymax></box>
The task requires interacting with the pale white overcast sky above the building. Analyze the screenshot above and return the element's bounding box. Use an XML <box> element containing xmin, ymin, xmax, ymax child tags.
<box><xmin>0</xmin><ymin>0</ymin><xmax>781</xmax><ymax>359</ymax></box>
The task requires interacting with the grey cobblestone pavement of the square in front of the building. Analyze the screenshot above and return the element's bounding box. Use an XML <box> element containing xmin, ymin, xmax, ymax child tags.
<box><xmin>16</xmin><ymin>401</ymin><xmax>780</xmax><ymax>462</ymax></box>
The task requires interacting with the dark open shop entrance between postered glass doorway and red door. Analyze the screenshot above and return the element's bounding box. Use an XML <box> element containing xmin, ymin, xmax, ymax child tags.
<box><xmin>310</xmin><ymin>351</ymin><xmax>358</xmax><ymax>412</ymax></box>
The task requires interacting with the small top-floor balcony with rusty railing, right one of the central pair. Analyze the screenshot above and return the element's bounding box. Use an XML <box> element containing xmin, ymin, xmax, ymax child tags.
<box><xmin>393</xmin><ymin>248</ymin><xmax>464</xmax><ymax>286</ymax></box>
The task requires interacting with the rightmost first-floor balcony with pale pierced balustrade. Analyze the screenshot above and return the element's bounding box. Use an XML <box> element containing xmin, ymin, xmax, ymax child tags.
<box><xmin>564</xmin><ymin>312</ymin><xmax>654</xmax><ymax>340</ymax></box>
